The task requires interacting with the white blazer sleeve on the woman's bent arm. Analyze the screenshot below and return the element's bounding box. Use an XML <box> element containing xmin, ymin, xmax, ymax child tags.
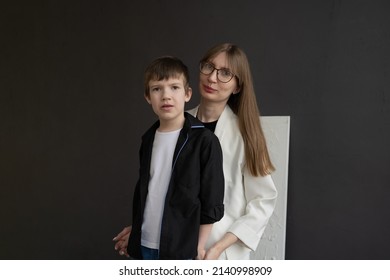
<box><xmin>228</xmin><ymin>168</ymin><xmax>277</xmax><ymax>250</ymax></box>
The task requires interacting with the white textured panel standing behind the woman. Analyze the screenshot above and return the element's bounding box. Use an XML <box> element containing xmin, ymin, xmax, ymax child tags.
<box><xmin>251</xmin><ymin>116</ymin><xmax>290</xmax><ymax>260</ymax></box>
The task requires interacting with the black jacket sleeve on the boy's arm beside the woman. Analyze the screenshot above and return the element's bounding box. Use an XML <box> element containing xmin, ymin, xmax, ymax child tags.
<box><xmin>200</xmin><ymin>132</ymin><xmax>225</xmax><ymax>224</ymax></box>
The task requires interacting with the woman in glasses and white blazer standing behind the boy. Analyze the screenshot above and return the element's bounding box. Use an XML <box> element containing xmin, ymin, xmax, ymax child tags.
<box><xmin>114</xmin><ymin>44</ymin><xmax>277</xmax><ymax>259</ymax></box>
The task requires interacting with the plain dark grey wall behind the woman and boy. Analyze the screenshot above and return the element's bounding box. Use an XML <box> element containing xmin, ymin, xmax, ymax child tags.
<box><xmin>0</xmin><ymin>0</ymin><xmax>390</xmax><ymax>259</ymax></box>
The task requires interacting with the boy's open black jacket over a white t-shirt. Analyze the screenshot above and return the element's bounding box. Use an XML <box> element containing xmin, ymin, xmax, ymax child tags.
<box><xmin>127</xmin><ymin>113</ymin><xmax>224</xmax><ymax>259</ymax></box>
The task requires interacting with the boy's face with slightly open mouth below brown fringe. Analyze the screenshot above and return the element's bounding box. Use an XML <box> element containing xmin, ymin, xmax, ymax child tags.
<box><xmin>145</xmin><ymin>75</ymin><xmax>192</xmax><ymax>126</ymax></box>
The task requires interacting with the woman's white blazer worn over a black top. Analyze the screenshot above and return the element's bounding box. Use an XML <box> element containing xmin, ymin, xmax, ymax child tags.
<box><xmin>188</xmin><ymin>105</ymin><xmax>277</xmax><ymax>260</ymax></box>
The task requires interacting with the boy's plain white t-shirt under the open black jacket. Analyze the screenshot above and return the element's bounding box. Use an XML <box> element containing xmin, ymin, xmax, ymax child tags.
<box><xmin>141</xmin><ymin>129</ymin><xmax>180</xmax><ymax>249</ymax></box>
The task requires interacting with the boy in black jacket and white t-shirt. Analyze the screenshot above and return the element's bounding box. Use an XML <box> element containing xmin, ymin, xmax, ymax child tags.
<box><xmin>127</xmin><ymin>57</ymin><xmax>224</xmax><ymax>259</ymax></box>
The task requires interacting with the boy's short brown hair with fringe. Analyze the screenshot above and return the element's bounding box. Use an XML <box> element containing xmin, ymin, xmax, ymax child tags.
<box><xmin>144</xmin><ymin>56</ymin><xmax>190</xmax><ymax>96</ymax></box>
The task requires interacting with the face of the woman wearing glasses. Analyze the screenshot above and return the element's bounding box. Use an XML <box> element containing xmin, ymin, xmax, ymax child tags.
<box><xmin>199</xmin><ymin>52</ymin><xmax>238</xmax><ymax>104</ymax></box>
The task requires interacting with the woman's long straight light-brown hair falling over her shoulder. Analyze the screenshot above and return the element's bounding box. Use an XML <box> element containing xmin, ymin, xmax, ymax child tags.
<box><xmin>201</xmin><ymin>43</ymin><xmax>275</xmax><ymax>176</ymax></box>
